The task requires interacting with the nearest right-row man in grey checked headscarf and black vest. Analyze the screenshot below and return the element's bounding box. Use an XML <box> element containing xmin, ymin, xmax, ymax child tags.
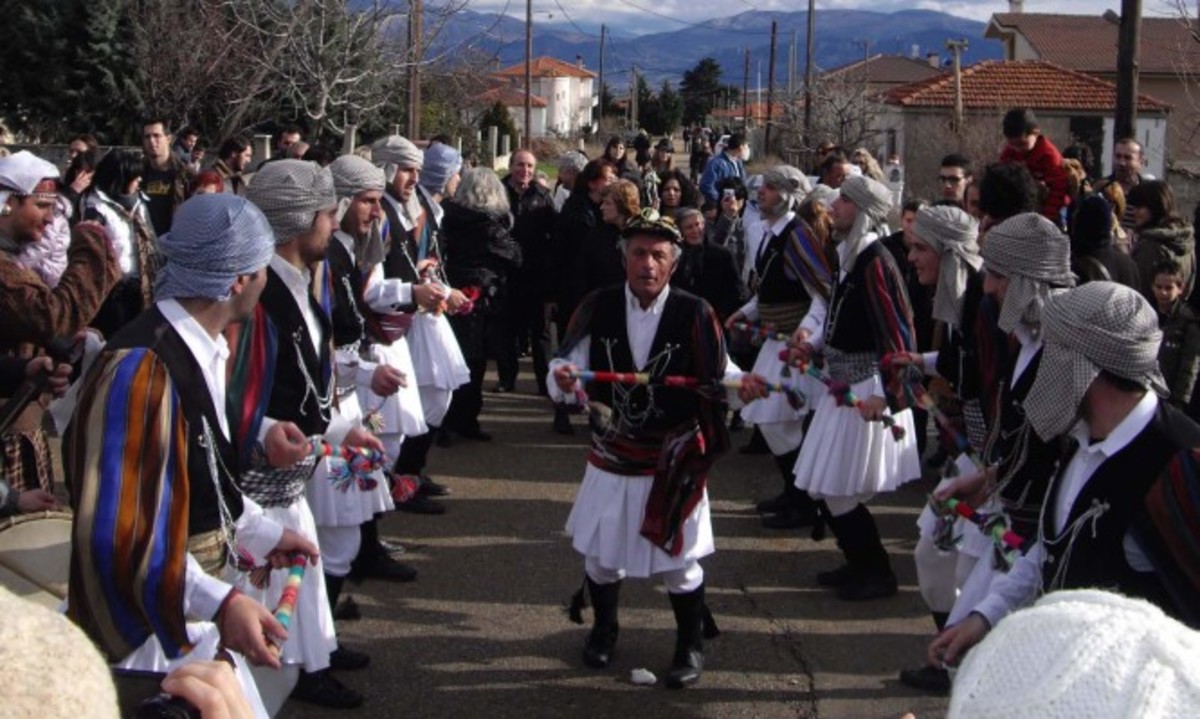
<box><xmin>930</xmin><ymin>280</ymin><xmax>1200</xmax><ymax>664</ymax></box>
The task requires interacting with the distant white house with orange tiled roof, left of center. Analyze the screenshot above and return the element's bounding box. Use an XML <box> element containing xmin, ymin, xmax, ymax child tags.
<box><xmin>488</xmin><ymin>56</ymin><xmax>600</xmax><ymax>137</ymax></box>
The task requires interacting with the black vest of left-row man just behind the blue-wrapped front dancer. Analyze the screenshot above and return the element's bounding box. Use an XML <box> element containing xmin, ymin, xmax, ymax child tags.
<box><xmin>259</xmin><ymin>268</ymin><xmax>336</xmax><ymax>436</ymax></box>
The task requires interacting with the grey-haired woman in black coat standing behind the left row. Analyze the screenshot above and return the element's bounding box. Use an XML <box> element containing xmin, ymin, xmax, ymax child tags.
<box><xmin>439</xmin><ymin>167</ymin><xmax>521</xmax><ymax>445</ymax></box>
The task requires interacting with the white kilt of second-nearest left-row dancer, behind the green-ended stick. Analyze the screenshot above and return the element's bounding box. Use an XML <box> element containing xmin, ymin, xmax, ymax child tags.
<box><xmin>236</xmin><ymin>496</ymin><xmax>337</xmax><ymax>671</ymax></box>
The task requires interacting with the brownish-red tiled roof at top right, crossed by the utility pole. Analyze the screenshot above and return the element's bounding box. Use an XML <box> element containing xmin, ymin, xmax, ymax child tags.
<box><xmin>984</xmin><ymin>12</ymin><xmax>1200</xmax><ymax>74</ymax></box>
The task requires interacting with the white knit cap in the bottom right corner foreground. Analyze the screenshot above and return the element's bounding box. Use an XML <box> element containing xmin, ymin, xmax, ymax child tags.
<box><xmin>948</xmin><ymin>589</ymin><xmax>1200</xmax><ymax>719</ymax></box>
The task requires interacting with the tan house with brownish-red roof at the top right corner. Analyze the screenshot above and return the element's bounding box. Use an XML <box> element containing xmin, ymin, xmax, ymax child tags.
<box><xmin>984</xmin><ymin>8</ymin><xmax>1200</xmax><ymax>161</ymax></box>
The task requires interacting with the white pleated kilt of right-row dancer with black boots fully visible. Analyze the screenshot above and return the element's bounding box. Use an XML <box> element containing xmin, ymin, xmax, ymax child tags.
<box><xmin>794</xmin><ymin>378</ymin><xmax>920</xmax><ymax>497</ymax></box>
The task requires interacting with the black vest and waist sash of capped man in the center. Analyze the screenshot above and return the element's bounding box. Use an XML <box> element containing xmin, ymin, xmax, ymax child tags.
<box><xmin>588</xmin><ymin>284</ymin><xmax>703</xmax><ymax>474</ymax></box>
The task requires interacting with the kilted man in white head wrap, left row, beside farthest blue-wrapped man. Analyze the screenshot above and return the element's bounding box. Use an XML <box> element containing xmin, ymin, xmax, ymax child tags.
<box><xmin>371</xmin><ymin>134</ymin><xmax>470</xmax><ymax>513</ymax></box>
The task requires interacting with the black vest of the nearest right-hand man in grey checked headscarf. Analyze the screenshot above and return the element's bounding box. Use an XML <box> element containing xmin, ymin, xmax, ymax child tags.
<box><xmin>1042</xmin><ymin>402</ymin><xmax>1200</xmax><ymax>610</ymax></box>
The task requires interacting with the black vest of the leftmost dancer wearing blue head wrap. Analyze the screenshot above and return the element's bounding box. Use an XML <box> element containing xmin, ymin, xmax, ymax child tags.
<box><xmin>106</xmin><ymin>307</ymin><xmax>242</xmax><ymax>537</ymax></box>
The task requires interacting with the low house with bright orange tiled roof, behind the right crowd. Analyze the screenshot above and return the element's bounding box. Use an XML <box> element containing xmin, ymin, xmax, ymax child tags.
<box><xmin>878</xmin><ymin>60</ymin><xmax>1171</xmax><ymax>202</ymax></box>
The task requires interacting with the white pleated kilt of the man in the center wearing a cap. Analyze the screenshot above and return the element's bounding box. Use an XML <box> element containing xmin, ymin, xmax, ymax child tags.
<box><xmin>566</xmin><ymin>463</ymin><xmax>716</xmax><ymax>577</ymax></box>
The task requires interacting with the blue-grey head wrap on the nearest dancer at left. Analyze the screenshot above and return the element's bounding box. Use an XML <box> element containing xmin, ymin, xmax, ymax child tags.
<box><xmin>155</xmin><ymin>190</ymin><xmax>274</xmax><ymax>300</ymax></box>
